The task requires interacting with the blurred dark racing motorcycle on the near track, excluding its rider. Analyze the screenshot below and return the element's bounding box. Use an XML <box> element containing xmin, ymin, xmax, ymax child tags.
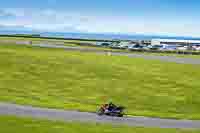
<box><xmin>97</xmin><ymin>104</ymin><xmax>125</xmax><ymax>117</ymax></box>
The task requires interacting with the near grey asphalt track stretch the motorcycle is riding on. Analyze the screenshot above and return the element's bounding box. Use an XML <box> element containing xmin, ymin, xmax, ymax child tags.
<box><xmin>0</xmin><ymin>103</ymin><xmax>200</xmax><ymax>129</ymax></box>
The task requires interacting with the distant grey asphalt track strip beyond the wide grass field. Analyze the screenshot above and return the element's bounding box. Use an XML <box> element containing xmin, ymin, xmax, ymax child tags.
<box><xmin>28</xmin><ymin>44</ymin><xmax>200</xmax><ymax>65</ymax></box>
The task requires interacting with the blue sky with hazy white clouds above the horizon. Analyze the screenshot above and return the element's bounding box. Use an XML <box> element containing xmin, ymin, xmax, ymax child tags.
<box><xmin>0</xmin><ymin>0</ymin><xmax>200</xmax><ymax>37</ymax></box>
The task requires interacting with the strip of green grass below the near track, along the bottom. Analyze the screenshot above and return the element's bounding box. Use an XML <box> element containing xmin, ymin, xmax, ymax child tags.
<box><xmin>0</xmin><ymin>116</ymin><xmax>200</xmax><ymax>133</ymax></box>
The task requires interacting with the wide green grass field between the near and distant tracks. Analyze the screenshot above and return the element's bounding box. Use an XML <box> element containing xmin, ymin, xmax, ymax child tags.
<box><xmin>0</xmin><ymin>45</ymin><xmax>200</xmax><ymax>119</ymax></box>
